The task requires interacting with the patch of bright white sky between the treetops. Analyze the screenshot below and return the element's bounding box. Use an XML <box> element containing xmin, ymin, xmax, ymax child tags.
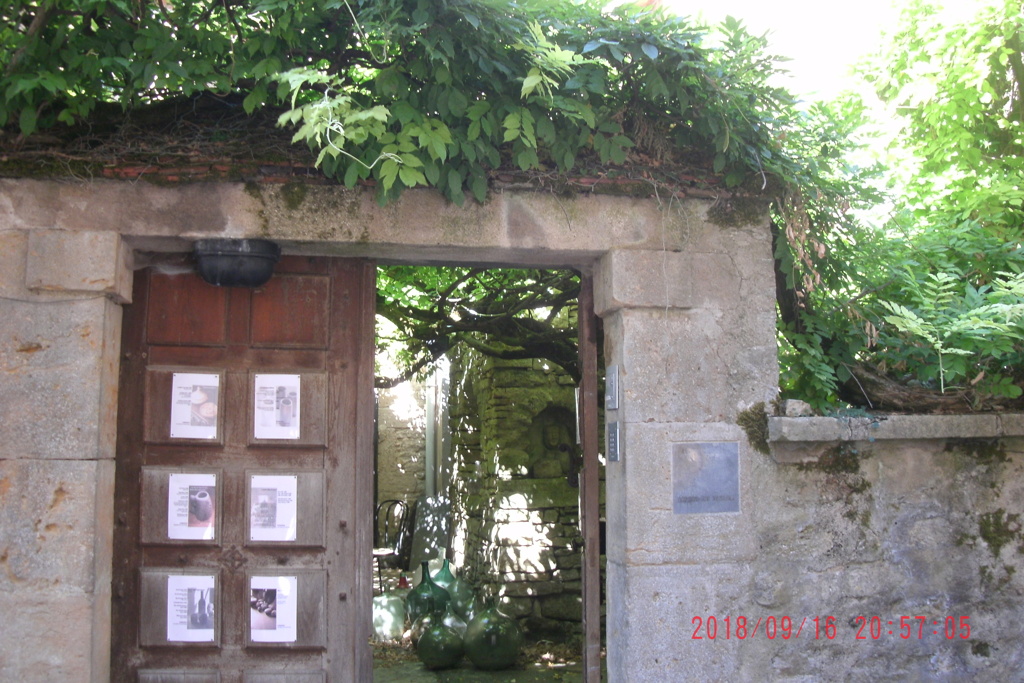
<box><xmin>665</xmin><ymin>0</ymin><xmax>905</xmax><ymax>99</ymax></box>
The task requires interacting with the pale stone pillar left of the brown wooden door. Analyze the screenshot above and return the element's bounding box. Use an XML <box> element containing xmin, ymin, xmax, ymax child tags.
<box><xmin>0</xmin><ymin>230</ymin><xmax>131</xmax><ymax>683</ymax></box>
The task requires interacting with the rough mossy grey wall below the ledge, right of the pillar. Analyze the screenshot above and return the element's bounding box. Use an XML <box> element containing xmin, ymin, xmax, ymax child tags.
<box><xmin>696</xmin><ymin>438</ymin><xmax>1024</xmax><ymax>681</ymax></box>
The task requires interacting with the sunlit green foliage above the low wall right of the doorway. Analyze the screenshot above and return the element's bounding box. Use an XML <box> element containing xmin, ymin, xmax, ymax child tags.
<box><xmin>776</xmin><ymin>0</ymin><xmax>1024</xmax><ymax>411</ymax></box>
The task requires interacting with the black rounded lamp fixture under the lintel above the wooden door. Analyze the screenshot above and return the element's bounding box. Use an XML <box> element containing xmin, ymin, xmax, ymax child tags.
<box><xmin>194</xmin><ymin>240</ymin><xmax>281</xmax><ymax>287</ymax></box>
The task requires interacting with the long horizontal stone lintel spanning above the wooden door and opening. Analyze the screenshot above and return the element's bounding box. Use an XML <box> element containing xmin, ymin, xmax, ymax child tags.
<box><xmin>0</xmin><ymin>178</ymin><xmax>696</xmax><ymax>269</ymax></box>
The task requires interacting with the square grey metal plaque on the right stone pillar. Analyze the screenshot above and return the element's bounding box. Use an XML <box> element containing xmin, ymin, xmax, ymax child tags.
<box><xmin>672</xmin><ymin>441</ymin><xmax>739</xmax><ymax>515</ymax></box>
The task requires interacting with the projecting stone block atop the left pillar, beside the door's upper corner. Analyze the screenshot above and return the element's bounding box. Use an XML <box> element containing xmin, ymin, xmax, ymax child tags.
<box><xmin>25</xmin><ymin>230</ymin><xmax>132</xmax><ymax>303</ymax></box>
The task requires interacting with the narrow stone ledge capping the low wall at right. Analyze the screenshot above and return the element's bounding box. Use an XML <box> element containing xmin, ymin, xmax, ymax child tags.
<box><xmin>768</xmin><ymin>413</ymin><xmax>1024</xmax><ymax>464</ymax></box>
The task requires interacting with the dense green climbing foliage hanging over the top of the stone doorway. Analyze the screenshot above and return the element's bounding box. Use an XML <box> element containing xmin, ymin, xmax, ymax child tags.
<box><xmin>0</xmin><ymin>0</ymin><xmax>791</xmax><ymax>204</ymax></box>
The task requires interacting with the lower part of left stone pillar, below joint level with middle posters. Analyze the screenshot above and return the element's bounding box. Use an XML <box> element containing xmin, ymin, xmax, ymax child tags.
<box><xmin>0</xmin><ymin>460</ymin><xmax>114</xmax><ymax>683</ymax></box>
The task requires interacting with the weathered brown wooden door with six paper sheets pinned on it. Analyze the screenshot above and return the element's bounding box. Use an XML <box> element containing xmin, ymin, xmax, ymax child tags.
<box><xmin>112</xmin><ymin>257</ymin><xmax>375</xmax><ymax>683</ymax></box>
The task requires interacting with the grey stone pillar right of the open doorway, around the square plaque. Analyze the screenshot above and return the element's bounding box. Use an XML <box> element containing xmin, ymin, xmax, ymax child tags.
<box><xmin>595</xmin><ymin>206</ymin><xmax>777</xmax><ymax>683</ymax></box>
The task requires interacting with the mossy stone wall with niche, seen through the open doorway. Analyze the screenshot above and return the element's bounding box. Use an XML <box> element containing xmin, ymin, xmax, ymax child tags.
<box><xmin>450</xmin><ymin>353</ymin><xmax>598</xmax><ymax>637</ymax></box>
